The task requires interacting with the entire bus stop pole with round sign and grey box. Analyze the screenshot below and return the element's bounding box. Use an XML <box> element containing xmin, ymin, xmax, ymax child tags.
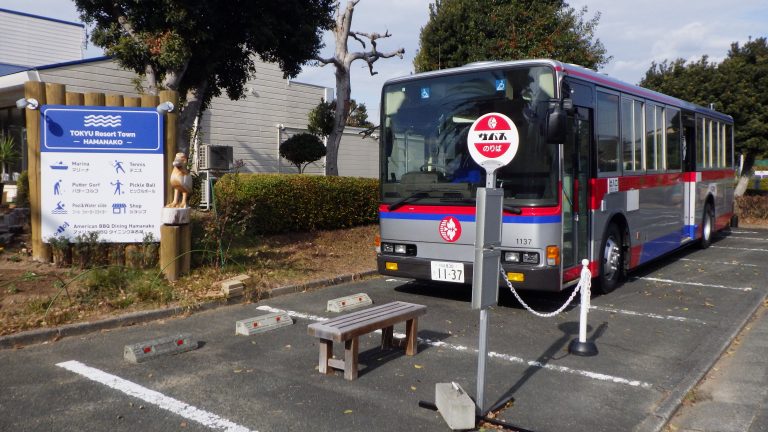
<box><xmin>467</xmin><ymin>113</ymin><xmax>519</xmax><ymax>415</ymax></box>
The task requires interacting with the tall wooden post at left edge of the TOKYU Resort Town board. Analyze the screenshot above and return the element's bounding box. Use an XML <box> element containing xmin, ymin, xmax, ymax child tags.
<box><xmin>24</xmin><ymin>81</ymin><xmax>50</xmax><ymax>262</ymax></box>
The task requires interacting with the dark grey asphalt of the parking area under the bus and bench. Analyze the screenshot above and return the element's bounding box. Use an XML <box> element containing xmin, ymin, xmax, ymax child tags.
<box><xmin>0</xmin><ymin>229</ymin><xmax>768</xmax><ymax>432</ymax></box>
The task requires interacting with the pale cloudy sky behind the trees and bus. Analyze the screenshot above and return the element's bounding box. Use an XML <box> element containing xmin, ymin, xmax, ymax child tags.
<box><xmin>0</xmin><ymin>0</ymin><xmax>768</xmax><ymax>123</ymax></box>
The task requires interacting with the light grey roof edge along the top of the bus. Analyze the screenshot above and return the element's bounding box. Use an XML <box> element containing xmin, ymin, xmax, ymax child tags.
<box><xmin>384</xmin><ymin>59</ymin><xmax>733</xmax><ymax>123</ymax></box>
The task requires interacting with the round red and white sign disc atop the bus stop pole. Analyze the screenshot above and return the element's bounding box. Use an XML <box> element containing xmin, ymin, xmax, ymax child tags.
<box><xmin>467</xmin><ymin>113</ymin><xmax>520</xmax><ymax>173</ymax></box>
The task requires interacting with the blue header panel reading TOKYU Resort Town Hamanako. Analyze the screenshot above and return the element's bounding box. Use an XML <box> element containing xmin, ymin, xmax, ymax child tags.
<box><xmin>40</xmin><ymin>105</ymin><xmax>163</xmax><ymax>153</ymax></box>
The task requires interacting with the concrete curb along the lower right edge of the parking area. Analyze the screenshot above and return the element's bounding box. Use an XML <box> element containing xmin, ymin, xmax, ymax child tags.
<box><xmin>634</xmin><ymin>295</ymin><xmax>768</xmax><ymax>432</ymax></box>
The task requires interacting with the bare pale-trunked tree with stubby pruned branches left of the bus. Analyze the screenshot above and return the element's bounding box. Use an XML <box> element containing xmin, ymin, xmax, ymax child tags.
<box><xmin>315</xmin><ymin>0</ymin><xmax>405</xmax><ymax>176</ymax></box>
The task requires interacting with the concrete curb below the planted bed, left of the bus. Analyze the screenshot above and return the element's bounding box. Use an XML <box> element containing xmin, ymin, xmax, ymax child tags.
<box><xmin>0</xmin><ymin>270</ymin><xmax>378</xmax><ymax>349</ymax></box>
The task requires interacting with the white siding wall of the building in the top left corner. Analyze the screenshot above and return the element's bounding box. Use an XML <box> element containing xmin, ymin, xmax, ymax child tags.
<box><xmin>0</xmin><ymin>10</ymin><xmax>85</xmax><ymax>66</ymax></box>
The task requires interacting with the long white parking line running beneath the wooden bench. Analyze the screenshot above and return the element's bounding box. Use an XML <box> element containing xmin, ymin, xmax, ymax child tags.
<box><xmin>257</xmin><ymin>306</ymin><xmax>653</xmax><ymax>389</ymax></box>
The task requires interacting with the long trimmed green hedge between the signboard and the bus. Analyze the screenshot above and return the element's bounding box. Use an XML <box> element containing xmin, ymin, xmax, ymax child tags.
<box><xmin>214</xmin><ymin>174</ymin><xmax>379</xmax><ymax>234</ymax></box>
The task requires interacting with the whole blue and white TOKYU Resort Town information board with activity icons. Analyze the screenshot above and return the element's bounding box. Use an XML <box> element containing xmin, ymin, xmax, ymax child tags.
<box><xmin>40</xmin><ymin>105</ymin><xmax>165</xmax><ymax>243</ymax></box>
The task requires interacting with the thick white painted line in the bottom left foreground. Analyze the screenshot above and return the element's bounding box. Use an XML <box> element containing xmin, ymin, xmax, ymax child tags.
<box><xmin>56</xmin><ymin>360</ymin><xmax>251</xmax><ymax>432</ymax></box>
